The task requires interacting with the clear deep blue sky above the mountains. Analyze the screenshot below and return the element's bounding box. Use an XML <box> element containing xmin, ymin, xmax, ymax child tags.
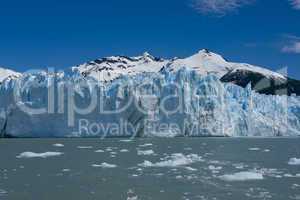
<box><xmin>0</xmin><ymin>0</ymin><xmax>300</xmax><ymax>79</ymax></box>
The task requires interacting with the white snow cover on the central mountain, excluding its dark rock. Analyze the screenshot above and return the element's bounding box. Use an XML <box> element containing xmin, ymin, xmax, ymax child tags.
<box><xmin>72</xmin><ymin>49</ymin><xmax>286</xmax><ymax>82</ymax></box>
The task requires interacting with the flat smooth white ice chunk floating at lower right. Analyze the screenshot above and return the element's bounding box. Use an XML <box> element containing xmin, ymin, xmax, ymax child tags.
<box><xmin>219</xmin><ymin>172</ymin><xmax>264</xmax><ymax>181</ymax></box>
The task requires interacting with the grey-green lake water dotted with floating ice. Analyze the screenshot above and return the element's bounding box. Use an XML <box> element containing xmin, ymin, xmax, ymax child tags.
<box><xmin>0</xmin><ymin>138</ymin><xmax>300</xmax><ymax>200</ymax></box>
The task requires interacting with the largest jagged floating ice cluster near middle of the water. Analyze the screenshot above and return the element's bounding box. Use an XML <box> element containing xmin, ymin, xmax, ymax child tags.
<box><xmin>139</xmin><ymin>153</ymin><xmax>203</xmax><ymax>167</ymax></box>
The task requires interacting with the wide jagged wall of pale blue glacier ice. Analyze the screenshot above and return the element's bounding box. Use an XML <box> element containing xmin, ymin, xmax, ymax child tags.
<box><xmin>0</xmin><ymin>67</ymin><xmax>300</xmax><ymax>137</ymax></box>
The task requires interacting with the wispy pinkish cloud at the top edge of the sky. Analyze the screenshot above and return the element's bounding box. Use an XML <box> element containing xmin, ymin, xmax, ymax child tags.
<box><xmin>192</xmin><ymin>0</ymin><xmax>255</xmax><ymax>16</ymax></box>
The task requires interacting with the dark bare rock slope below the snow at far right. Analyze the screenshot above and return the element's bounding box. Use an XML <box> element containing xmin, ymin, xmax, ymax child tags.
<box><xmin>221</xmin><ymin>70</ymin><xmax>300</xmax><ymax>96</ymax></box>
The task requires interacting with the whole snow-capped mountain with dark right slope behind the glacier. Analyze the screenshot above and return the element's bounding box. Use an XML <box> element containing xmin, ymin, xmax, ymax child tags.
<box><xmin>72</xmin><ymin>49</ymin><xmax>300</xmax><ymax>95</ymax></box>
